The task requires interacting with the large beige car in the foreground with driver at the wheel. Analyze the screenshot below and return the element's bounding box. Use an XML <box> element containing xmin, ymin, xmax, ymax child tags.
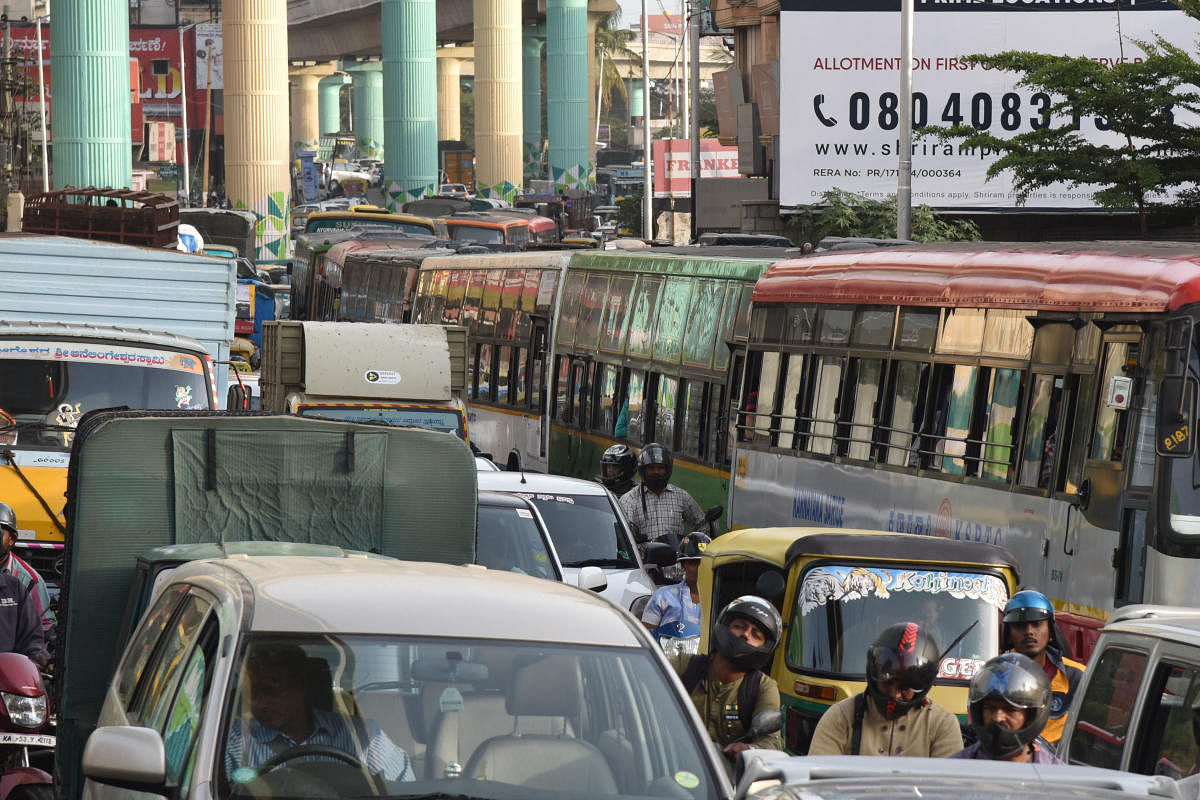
<box><xmin>83</xmin><ymin>554</ymin><xmax>733</xmax><ymax>800</ymax></box>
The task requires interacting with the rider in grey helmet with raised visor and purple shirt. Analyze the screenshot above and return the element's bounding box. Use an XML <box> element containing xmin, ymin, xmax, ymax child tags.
<box><xmin>950</xmin><ymin>652</ymin><xmax>1063</xmax><ymax>764</ymax></box>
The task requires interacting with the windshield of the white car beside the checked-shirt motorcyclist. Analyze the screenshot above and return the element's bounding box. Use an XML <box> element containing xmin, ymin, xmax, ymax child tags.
<box><xmin>521</xmin><ymin>492</ymin><xmax>637</xmax><ymax>570</ymax></box>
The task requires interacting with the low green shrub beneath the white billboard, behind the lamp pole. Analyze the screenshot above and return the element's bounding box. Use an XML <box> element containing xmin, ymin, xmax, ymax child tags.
<box><xmin>788</xmin><ymin>188</ymin><xmax>979</xmax><ymax>242</ymax></box>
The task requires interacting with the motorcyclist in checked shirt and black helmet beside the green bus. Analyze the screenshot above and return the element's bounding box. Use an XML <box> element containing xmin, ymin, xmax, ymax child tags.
<box><xmin>619</xmin><ymin>441</ymin><xmax>708</xmax><ymax>542</ymax></box>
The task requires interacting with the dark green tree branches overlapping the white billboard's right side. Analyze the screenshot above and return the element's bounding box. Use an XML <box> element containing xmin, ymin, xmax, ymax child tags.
<box><xmin>925</xmin><ymin>0</ymin><xmax>1200</xmax><ymax>235</ymax></box>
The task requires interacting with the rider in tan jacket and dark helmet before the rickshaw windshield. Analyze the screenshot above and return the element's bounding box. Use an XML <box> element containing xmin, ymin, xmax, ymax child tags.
<box><xmin>809</xmin><ymin>622</ymin><xmax>962</xmax><ymax>758</ymax></box>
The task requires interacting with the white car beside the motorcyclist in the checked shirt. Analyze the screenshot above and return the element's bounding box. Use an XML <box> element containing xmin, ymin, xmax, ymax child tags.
<box><xmin>478</xmin><ymin>471</ymin><xmax>655</xmax><ymax>614</ymax></box>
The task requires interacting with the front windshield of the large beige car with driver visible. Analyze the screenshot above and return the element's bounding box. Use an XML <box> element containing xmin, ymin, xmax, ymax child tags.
<box><xmin>215</xmin><ymin>632</ymin><xmax>718</xmax><ymax>800</ymax></box>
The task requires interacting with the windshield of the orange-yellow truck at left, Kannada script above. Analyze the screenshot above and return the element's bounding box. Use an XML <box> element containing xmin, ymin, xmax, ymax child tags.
<box><xmin>0</xmin><ymin>341</ymin><xmax>211</xmax><ymax>444</ymax></box>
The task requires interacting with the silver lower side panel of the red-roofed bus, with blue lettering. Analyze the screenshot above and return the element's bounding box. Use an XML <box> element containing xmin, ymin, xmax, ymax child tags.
<box><xmin>732</xmin><ymin>450</ymin><xmax>1123</xmax><ymax>616</ymax></box>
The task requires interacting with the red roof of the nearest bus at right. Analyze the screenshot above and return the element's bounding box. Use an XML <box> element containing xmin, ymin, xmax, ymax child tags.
<box><xmin>751</xmin><ymin>241</ymin><xmax>1200</xmax><ymax>312</ymax></box>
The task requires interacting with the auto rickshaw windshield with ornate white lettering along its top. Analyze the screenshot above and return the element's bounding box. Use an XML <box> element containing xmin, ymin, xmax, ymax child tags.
<box><xmin>787</xmin><ymin>563</ymin><xmax>1008</xmax><ymax>682</ymax></box>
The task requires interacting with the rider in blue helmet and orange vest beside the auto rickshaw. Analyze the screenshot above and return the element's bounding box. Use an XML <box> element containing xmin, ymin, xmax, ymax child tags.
<box><xmin>1004</xmin><ymin>589</ymin><xmax>1085</xmax><ymax>745</ymax></box>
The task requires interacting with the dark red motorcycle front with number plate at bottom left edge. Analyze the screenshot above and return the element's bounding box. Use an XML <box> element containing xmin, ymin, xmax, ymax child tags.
<box><xmin>0</xmin><ymin>652</ymin><xmax>56</xmax><ymax>800</ymax></box>
